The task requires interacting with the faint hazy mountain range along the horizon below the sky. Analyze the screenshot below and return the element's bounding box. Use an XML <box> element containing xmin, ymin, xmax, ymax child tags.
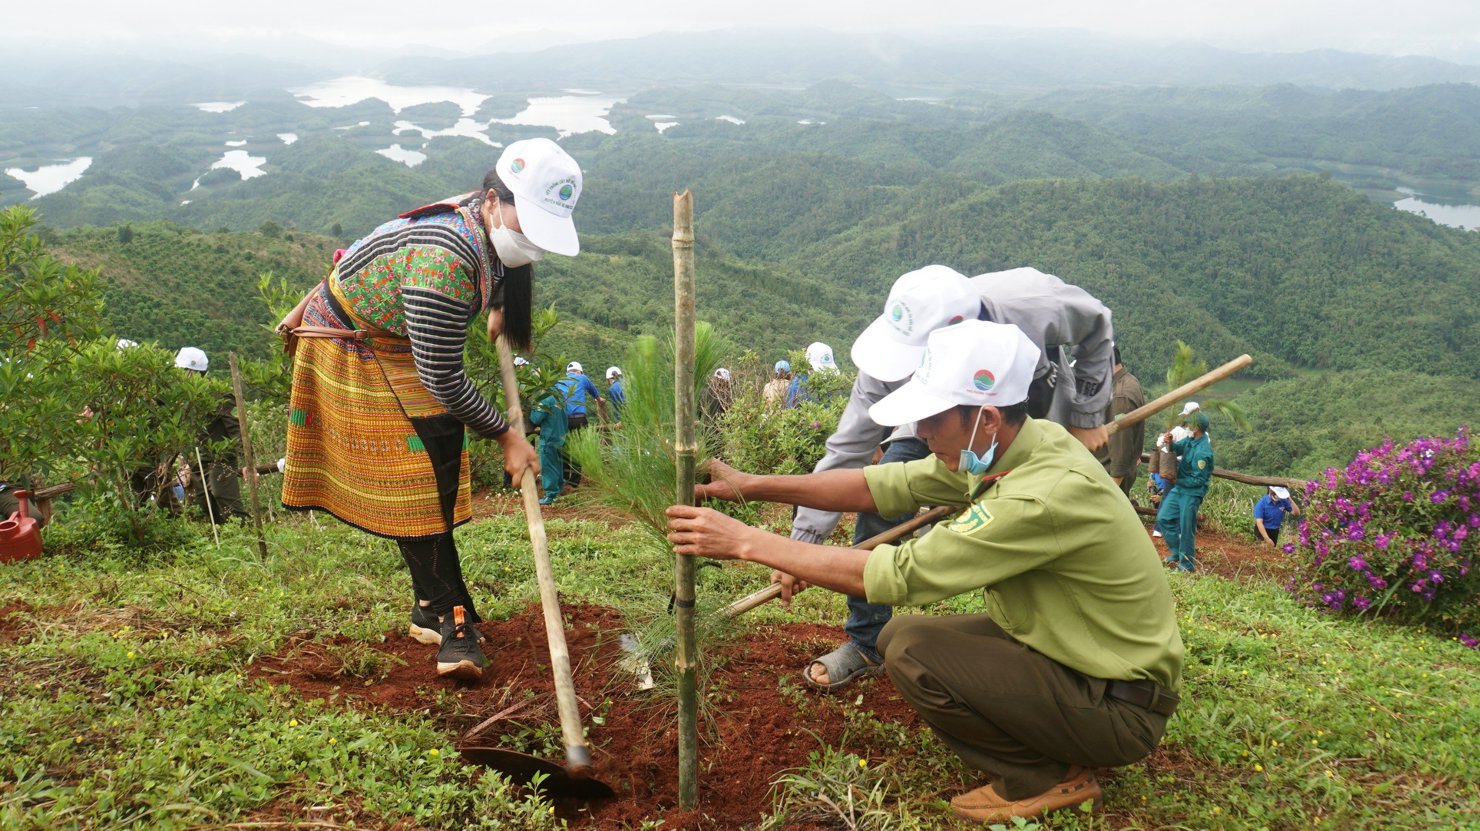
<box><xmin>0</xmin><ymin>30</ymin><xmax>1480</xmax><ymax>108</ymax></box>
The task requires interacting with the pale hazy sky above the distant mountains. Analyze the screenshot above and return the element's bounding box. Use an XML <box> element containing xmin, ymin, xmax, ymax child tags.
<box><xmin>11</xmin><ymin>0</ymin><xmax>1480</xmax><ymax>62</ymax></box>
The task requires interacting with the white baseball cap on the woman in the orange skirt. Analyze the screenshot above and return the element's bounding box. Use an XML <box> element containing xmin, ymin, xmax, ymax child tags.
<box><xmin>497</xmin><ymin>138</ymin><xmax>582</xmax><ymax>256</ymax></box>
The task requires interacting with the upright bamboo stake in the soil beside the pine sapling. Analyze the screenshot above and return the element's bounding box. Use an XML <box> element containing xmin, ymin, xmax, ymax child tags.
<box><xmin>673</xmin><ymin>190</ymin><xmax>699</xmax><ymax>810</ymax></box>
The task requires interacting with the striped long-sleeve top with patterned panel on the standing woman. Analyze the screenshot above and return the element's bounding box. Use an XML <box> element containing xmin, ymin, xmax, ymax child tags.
<box><xmin>337</xmin><ymin>200</ymin><xmax>509</xmax><ymax>438</ymax></box>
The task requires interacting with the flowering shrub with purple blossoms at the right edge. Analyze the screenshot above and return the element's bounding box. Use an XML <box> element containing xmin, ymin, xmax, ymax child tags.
<box><xmin>1285</xmin><ymin>428</ymin><xmax>1480</xmax><ymax>649</ymax></box>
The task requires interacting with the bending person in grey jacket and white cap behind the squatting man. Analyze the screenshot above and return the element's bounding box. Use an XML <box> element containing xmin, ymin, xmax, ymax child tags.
<box><xmin>773</xmin><ymin>265</ymin><xmax>1114</xmax><ymax>689</ymax></box>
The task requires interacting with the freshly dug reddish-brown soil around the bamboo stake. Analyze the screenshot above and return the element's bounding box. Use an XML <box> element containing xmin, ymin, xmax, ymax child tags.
<box><xmin>252</xmin><ymin>604</ymin><xmax>925</xmax><ymax>830</ymax></box>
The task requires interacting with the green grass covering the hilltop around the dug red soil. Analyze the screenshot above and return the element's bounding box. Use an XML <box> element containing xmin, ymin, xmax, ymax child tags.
<box><xmin>0</xmin><ymin>517</ymin><xmax>1480</xmax><ymax>830</ymax></box>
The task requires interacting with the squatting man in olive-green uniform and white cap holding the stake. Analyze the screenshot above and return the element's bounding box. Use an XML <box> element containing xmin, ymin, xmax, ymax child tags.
<box><xmin>667</xmin><ymin>320</ymin><xmax>1183</xmax><ymax>822</ymax></box>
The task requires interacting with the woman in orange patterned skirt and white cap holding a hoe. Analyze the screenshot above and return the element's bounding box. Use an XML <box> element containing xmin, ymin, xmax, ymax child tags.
<box><xmin>280</xmin><ymin>139</ymin><xmax>582</xmax><ymax>680</ymax></box>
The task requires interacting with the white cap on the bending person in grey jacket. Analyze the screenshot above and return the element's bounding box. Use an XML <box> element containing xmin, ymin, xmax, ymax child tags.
<box><xmin>852</xmin><ymin>265</ymin><xmax>981</xmax><ymax>381</ymax></box>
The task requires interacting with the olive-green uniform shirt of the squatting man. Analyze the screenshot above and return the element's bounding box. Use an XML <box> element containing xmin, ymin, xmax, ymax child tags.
<box><xmin>863</xmin><ymin>419</ymin><xmax>1183</xmax><ymax>692</ymax></box>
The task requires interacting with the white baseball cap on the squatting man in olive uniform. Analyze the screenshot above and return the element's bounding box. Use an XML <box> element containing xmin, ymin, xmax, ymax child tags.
<box><xmin>869</xmin><ymin>320</ymin><xmax>1039</xmax><ymax>427</ymax></box>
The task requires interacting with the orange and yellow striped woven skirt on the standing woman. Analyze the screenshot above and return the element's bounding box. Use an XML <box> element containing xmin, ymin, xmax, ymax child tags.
<box><xmin>283</xmin><ymin>277</ymin><xmax>472</xmax><ymax>539</ymax></box>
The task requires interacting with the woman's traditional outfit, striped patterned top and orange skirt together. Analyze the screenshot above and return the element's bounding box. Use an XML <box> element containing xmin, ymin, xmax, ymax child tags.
<box><xmin>283</xmin><ymin>197</ymin><xmax>508</xmax><ymax>539</ymax></box>
